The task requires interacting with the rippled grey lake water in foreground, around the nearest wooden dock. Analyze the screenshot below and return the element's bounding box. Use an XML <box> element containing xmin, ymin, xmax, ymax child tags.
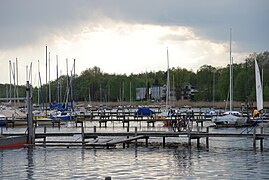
<box><xmin>0</xmin><ymin>122</ymin><xmax>269</xmax><ymax>179</ymax></box>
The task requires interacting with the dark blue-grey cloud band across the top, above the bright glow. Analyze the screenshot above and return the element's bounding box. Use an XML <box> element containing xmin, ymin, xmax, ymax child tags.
<box><xmin>0</xmin><ymin>0</ymin><xmax>269</xmax><ymax>51</ymax></box>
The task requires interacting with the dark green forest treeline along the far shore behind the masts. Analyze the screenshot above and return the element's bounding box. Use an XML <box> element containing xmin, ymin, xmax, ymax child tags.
<box><xmin>0</xmin><ymin>51</ymin><xmax>269</xmax><ymax>103</ymax></box>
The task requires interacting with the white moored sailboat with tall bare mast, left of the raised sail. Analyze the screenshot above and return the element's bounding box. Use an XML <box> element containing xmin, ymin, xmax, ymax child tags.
<box><xmin>212</xmin><ymin>29</ymin><xmax>247</xmax><ymax>125</ymax></box>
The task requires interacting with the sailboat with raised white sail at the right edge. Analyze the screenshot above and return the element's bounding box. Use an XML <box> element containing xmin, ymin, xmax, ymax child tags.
<box><xmin>253</xmin><ymin>58</ymin><xmax>269</xmax><ymax>126</ymax></box>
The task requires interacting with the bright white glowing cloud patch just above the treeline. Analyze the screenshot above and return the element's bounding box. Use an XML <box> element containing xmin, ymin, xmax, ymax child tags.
<box><xmin>0</xmin><ymin>21</ymin><xmax>249</xmax><ymax>85</ymax></box>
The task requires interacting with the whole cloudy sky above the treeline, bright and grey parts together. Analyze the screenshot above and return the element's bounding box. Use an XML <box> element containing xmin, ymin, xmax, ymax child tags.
<box><xmin>0</xmin><ymin>0</ymin><xmax>269</xmax><ymax>85</ymax></box>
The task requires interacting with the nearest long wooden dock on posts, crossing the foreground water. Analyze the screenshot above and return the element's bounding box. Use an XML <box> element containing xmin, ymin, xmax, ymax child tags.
<box><xmin>3</xmin><ymin>126</ymin><xmax>269</xmax><ymax>151</ymax></box>
